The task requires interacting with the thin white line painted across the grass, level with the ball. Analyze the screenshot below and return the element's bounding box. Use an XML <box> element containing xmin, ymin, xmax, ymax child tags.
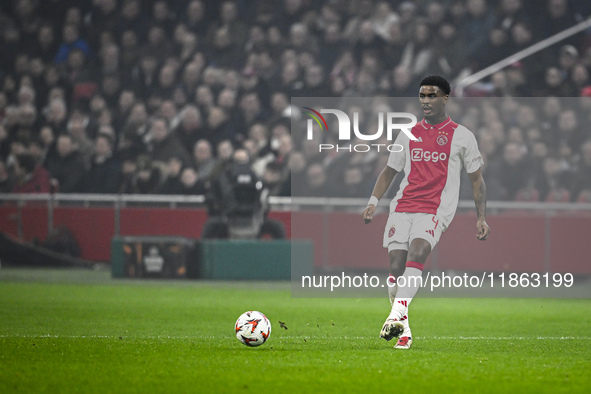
<box><xmin>0</xmin><ymin>334</ymin><xmax>591</xmax><ymax>341</ymax></box>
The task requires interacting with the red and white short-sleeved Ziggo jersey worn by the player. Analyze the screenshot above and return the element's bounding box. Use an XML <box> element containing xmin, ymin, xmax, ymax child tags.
<box><xmin>388</xmin><ymin>117</ymin><xmax>484</xmax><ymax>228</ymax></box>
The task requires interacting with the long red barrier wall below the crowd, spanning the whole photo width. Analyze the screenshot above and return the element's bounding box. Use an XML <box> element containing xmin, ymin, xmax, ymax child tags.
<box><xmin>0</xmin><ymin>204</ymin><xmax>591</xmax><ymax>274</ymax></box>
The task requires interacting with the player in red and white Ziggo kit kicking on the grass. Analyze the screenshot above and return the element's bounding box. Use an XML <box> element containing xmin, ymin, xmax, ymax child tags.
<box><xmin>362</xmin><ymin>76</ymin><xmax>490</xmax><ymax>349</ymax></box>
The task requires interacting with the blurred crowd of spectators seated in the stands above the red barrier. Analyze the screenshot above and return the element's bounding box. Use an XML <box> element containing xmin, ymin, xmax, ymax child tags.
<box><xmin>0</xmin><ymin>0</ymin><xmax>591</xmax><ymax>201</ymax></box>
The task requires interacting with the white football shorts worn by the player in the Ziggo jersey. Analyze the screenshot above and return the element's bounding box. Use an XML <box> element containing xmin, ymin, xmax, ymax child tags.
<box><xmin>384</xmin><ymin>212</ymin><xmax>445</xmax><ymax>252</ymax></box>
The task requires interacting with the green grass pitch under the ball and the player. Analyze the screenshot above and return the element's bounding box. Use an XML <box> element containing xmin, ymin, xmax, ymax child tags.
<box><xmin>0</xmin><ymin>269</ymin><xmax>591</xmax><ymax>393</ymax></box>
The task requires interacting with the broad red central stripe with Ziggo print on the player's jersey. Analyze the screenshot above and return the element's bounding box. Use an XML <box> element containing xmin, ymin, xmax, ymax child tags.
<box><xmin>396</xmin><ymin>118</ymin><xmax>458</xmax><ymax>215</ymax></box>
